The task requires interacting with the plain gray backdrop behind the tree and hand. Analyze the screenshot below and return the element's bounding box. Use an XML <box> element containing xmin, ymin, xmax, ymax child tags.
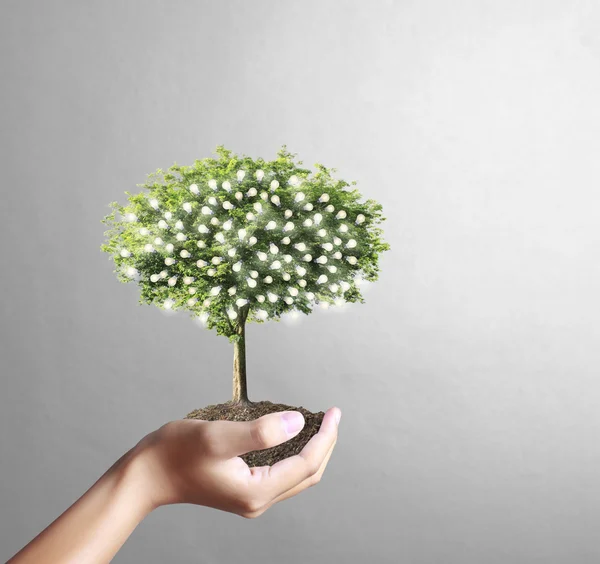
<box><xmin>0</xmin><ymin>0</ymin><xmax>600</xmax><ymax>564</ymax></box>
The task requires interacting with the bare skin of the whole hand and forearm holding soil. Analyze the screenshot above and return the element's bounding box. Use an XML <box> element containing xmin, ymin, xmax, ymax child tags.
<box><xmin>7</xmin><ymin>407</ymin><xmax>341</xmax><ymax>564</ymax></box>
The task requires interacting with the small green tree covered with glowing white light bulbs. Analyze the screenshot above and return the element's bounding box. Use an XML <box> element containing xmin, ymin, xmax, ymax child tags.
<box><xmin>102</xmin><ymin>145</ymin><xmax>389</xmax><ymax>404</ymax></box>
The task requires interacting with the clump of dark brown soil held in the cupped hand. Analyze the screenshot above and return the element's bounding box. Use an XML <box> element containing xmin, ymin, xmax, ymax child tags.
<box><xmin>185</xmin><ymin>401</ymin><xmax>325</xmax><ymax>467</ymax></box>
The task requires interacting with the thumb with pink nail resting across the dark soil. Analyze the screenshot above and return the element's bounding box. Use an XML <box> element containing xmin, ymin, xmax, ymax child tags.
<box><xmin>207</xmin><ymin>411</ymin><xmax>304</xmax><ymax>458</ymax></box>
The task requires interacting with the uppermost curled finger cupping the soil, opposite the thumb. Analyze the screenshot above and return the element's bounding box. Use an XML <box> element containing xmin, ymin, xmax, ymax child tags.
<box><xmin>254</xmin><ymin>407</ymin><xmax>341</xmax><ymax>500</ymax></box>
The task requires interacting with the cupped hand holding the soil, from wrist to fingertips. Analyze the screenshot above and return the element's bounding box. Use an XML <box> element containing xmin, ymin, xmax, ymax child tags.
<box><xmin>135</xmin><ymin>408</ymin><xmax>341</xmax><ymax>519</ymax></box>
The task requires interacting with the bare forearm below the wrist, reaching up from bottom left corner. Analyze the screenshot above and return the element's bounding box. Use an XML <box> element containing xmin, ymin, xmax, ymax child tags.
<box><xmin>7</xmin><ymin>450</ymin><xmax>152</xmax><ymax>564</ymax></box>
